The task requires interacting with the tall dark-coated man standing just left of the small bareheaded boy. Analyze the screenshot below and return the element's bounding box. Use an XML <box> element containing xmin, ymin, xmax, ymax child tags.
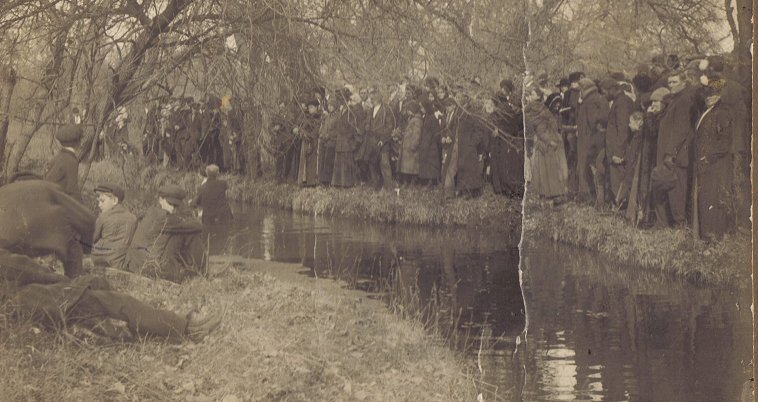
<box><xmin>605</xmin><ymin>79</ymin><xmax>634</xmax><ymax>206</ymax></box>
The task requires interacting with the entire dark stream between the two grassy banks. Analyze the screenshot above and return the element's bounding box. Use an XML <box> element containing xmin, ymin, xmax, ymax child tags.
<box><xmin>206</xmin><ymin>207</ymin><xmax>751</xmax><ymax>401</ymax></box>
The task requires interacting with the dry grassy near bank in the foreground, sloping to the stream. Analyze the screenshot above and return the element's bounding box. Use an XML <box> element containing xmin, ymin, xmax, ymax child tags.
<box><xmin>0</xmin><ymin>260</ymin><xmax>481</xmax><ymax>402</ymax></box>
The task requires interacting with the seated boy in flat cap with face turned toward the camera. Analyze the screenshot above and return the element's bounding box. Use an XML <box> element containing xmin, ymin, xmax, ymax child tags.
<box><xmin>92</xmin><ymin>183</ymin><xmax>137</xmax><ymax>267</ymax></box>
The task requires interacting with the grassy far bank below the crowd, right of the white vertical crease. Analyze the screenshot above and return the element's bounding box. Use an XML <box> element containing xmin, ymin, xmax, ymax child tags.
<box><xmin>524</xmin><ymin>203</ymin><xmax>751</xmax><ymax>286</ymax></box>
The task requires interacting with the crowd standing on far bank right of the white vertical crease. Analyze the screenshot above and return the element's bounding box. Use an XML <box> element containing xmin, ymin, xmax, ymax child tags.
<box><xmin>524</xmin><ymin>55</ymin><xmax>750</xmax><ymax>239</ymax></box>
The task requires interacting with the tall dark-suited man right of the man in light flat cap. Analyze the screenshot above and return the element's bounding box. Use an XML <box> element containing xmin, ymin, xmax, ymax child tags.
<box><xmin>656</xmin><ymin>72</ymin><xmax>698</xmax><ymax>226</ymax></box>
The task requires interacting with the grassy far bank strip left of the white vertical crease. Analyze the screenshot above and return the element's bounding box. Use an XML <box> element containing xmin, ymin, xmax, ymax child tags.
<box><xmin>80</xmin><ymin>161</ymin><xmax>521</xmax><ymax>231</ymax></box>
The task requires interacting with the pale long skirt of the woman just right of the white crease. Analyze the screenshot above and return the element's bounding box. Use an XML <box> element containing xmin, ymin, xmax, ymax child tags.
<box><xmin>530</xmin><ymin>142</ymin><xmax>568</xmax><ymax>197</ymax></box>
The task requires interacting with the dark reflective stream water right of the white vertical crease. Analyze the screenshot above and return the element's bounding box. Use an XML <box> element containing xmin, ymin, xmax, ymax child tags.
<box><xmin>523</xmin><ymin>242</ymin><xmax>751</xmax><ymax>401</ymax></box>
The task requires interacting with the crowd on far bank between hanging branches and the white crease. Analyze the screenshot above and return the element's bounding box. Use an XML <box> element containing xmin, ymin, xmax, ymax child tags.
<box><xmin>270</xmin><ymin>78</ymin><xmax>524</xmax><ymax>197</ymax></box>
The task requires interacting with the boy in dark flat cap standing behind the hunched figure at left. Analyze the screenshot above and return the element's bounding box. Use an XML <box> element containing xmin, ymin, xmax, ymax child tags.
<box><xmin>45</xmin><ymin>124</ymin><xmax>82</xmax><ymax>201</ymax></box>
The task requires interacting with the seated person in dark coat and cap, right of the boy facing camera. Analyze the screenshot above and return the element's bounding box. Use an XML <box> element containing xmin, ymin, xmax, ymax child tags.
<box><xmin>124</xmin><ymin>184</ymin><xmax>206</xmax><ymax>282</ymax></box>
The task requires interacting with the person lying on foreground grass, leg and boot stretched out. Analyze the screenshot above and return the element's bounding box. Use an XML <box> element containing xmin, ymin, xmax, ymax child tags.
<box><xmin>0</xmin><ymin>248</ymin><xmax>223</xmax><ymax>342</ymax></box>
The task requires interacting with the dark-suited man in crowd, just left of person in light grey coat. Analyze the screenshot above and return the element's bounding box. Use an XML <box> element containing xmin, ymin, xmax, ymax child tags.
<box><xmin>357</xmin><ymin>91</ymin><xmax>397</xmax><ymax>189</ymax></box>
